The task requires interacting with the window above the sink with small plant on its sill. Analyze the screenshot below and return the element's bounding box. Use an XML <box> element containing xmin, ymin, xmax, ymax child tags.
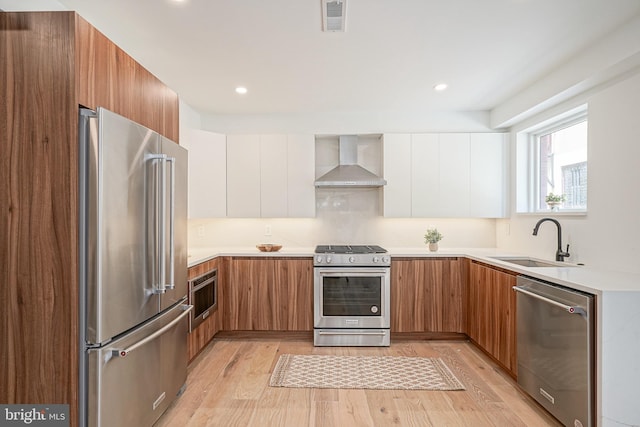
<box><xmin>517</xmin><ymin>107</ymin><xmax>588</xmax><ymax>212</ymax></box>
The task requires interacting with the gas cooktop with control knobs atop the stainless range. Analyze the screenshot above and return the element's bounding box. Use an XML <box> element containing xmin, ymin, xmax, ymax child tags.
<box><xmin>313</xmin><ymin>245</ymin><xmax>391</xmax><ymax>267</ymax></box>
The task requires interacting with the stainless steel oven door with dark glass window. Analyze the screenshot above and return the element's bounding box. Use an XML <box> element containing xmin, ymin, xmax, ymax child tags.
<box><xmin>314</xmin><ymin>267</ymin><xmax>390</xmax><ymax>329</ymax></box>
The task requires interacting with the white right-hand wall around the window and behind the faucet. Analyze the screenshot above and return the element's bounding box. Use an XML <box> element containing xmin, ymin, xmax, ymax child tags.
<box><xmin>496</xmin><ymin>70</ymin><xmax>640</xmax><ymax>273</ymax></box>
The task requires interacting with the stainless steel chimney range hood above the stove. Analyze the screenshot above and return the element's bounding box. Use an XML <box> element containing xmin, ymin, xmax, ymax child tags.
<box><xmin>315</xmin><ymin>135</ymin><xmax>387</xmax><ymax>187</ymax></box>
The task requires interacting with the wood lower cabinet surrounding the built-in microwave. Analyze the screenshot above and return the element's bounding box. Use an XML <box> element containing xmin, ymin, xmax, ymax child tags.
<box><xmin>187</xmin><ymin>258</ymin><xmax>224</xmax><ymax>361</ymax></box>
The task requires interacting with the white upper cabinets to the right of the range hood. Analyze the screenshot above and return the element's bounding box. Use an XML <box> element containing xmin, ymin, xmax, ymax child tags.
<box><xmin>384</xmin><ymin>133</ymin><xmax>507</xmax><ymax>218</ymax></box>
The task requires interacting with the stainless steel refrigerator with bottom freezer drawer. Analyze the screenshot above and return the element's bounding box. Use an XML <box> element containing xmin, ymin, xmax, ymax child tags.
<box><xmin>79</xmin><ymin>108</ymin><xmax>191</xmax><ymax>427</ymax></box>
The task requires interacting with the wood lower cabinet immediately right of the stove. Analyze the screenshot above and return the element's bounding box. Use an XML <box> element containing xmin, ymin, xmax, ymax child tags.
<box><xmin>391</xmin><ymin>257</ymin><xmax>467</xmax><ymax>333</ymax></box>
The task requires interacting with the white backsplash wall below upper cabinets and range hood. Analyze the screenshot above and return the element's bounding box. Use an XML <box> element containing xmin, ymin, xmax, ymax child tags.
<box><xmin>189</xmin><ymin>189</ymin><xmax>496</xmax><ymax>251</ymax></box>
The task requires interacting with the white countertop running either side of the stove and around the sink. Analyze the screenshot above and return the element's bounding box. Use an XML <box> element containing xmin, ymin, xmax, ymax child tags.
<box><xmin>188</xmin><ymin>246</ymin><xmax>640</xmax><ymax>295</ymax></box>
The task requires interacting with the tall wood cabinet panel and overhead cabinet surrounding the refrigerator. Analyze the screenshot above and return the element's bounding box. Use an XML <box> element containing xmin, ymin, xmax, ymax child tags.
<box><xmin>0</xmin><ymin>12</ymin><xmax>178</xmax><ymax>426</ymax></box>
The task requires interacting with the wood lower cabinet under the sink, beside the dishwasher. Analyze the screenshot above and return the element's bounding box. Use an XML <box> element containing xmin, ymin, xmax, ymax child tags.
<box><xmin>467</xmin><ymin>261</ymin><xmax>517</xmax><ymax>377</ymax></box>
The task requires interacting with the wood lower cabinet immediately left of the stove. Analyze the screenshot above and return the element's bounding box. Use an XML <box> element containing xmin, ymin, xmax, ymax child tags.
<box><xmin>222</xmin><ymin>257</ymin><xmax>313</xmax><ymax>331</ymax></box>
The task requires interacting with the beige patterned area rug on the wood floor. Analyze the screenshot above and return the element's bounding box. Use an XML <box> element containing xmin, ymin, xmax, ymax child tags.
<box><xmin>269</xmin><ymin>354</ymin><xmax>464</xmax><ymax>390</ymax></box>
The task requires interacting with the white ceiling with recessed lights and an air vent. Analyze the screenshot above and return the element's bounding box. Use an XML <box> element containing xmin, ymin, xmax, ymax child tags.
<box><xmin>0</xmin><ymin>0</ymin><xmax>640</xmax><ymax>120</ymax></box>
